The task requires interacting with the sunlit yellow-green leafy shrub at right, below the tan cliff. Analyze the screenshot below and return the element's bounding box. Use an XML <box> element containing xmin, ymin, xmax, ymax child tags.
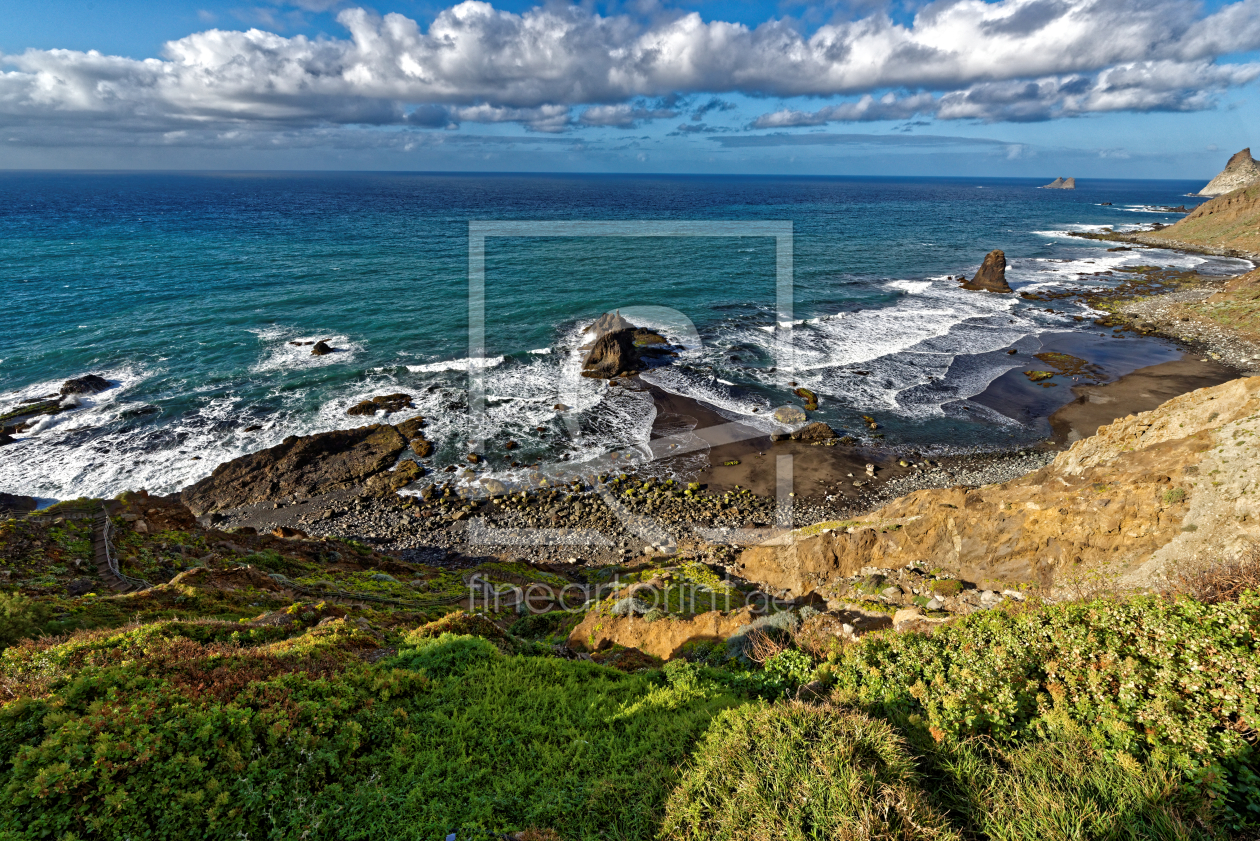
<box><xmin>832</xmin><ymin>594</ymin><xmax>1260</xmax><ymax>825</ymax></box>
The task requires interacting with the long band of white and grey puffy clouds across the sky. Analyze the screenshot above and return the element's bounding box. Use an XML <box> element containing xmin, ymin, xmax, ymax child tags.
<box><xmin>0</xmin><ymin>0</ymin><xmax>1260</xmax><ymax>142</ymax></box>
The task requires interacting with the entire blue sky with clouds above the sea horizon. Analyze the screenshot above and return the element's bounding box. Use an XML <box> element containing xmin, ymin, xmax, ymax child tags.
<box><xmin>0</xmin><ymin>0</ymin><xmax>1260</xmax><ymax>180</ymax></box>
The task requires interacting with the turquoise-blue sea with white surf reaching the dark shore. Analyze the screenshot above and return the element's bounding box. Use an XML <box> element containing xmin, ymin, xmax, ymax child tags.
<box><xmin>0</xmin><ymin>173</ymin><xmax>1246</xmax><ymax>498</ymax></box>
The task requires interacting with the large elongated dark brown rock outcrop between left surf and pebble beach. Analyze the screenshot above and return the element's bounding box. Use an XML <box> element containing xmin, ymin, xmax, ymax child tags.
<box><xmin>180</xmin><ymin>424</ymin><xmax>407</xmax><ymax>516</ymax></box>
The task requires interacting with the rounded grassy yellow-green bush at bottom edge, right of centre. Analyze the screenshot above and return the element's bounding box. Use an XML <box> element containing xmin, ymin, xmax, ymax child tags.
<box><xmin>660</xmin><ymin>702</ymin><xmax>958</xmax><ymax>841</ymax></box>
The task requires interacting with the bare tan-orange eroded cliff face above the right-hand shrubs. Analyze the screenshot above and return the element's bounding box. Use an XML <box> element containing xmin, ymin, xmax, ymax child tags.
<box><xmin>738</xmin><ymin>377</ymin><xmax>1260</xmax><ymax>598</ymax></box>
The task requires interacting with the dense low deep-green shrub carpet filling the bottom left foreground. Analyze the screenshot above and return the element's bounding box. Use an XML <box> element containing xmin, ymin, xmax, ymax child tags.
<box><xmin>0</xmin><ymin>628</ymin><xmax>737</xmax><ymax>841</ymax></box>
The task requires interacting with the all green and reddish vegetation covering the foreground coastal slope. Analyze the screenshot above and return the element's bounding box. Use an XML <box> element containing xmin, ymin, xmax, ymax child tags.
<box><xmin>0</xmin><ymin>504</ymin><xmax>1260</xmax><ymax>841</ymax></box>
